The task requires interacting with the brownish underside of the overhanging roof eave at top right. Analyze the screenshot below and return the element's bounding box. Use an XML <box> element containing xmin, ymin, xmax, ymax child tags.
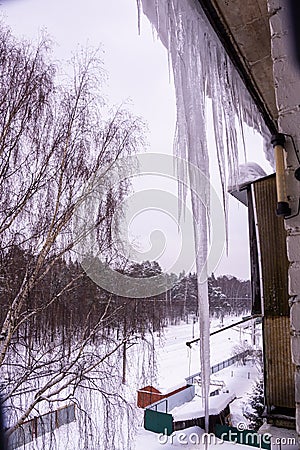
<box><xmin>198</xmin><ymin>0</ymin><xmax>278</xmax><ymax>133</ymax></box>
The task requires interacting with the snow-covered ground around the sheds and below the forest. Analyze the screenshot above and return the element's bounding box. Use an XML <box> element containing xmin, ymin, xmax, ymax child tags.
<box><xmin>19</xmin><ymin>317</ymin><xmax>261</xmax><ymax>450</ymax></box>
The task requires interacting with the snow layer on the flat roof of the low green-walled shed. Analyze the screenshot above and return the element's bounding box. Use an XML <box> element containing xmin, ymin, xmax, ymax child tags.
<box><xmin>170</xmin><ymin>392</ymin><xmax>236</xmax><ymax>421</ymax></box>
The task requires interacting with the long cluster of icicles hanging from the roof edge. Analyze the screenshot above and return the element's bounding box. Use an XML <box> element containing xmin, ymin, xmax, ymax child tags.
<box><xmin>137</xmin><ymin>0</ymin><xmax>273</xmax><ymax>427</ymax></box>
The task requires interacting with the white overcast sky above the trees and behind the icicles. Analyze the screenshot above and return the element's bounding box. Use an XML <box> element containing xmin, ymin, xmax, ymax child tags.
<box><xmin>0</xmin><ymin>0</ymin><xmax>270</xmax><ymax>279</ymax></box>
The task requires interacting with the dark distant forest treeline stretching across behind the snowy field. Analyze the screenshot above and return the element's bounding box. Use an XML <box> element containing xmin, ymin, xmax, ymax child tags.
<box><xmin>0</xmin><ymin>246</ymin><xmax>251</xmax><ymax>341</ymax></box>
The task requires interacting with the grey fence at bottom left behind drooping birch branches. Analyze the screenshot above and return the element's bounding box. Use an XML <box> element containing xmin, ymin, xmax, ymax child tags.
<box><xmin>8</xmin><ymin>403</ymin><xmax>76</xmax><ymax>450</ymax></box>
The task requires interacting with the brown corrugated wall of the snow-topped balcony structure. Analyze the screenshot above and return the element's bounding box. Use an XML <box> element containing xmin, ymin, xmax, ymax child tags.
<box><xmin>253</xmin><ymin>175</ymin><xmax>295</xmax><ymax>410</ymax></box>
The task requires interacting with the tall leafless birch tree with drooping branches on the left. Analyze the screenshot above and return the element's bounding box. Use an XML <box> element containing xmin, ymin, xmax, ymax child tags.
<box><xmin>0</xmin><ymin>25</ymin><xmax>143</xmax><ymax>450</ymax></box>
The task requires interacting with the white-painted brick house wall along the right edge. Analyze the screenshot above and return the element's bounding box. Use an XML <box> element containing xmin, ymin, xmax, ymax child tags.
<box><xmin>268</xmin><ymin>0</ymin><xmax>300</xmax><ymax>435</ymax></box>
